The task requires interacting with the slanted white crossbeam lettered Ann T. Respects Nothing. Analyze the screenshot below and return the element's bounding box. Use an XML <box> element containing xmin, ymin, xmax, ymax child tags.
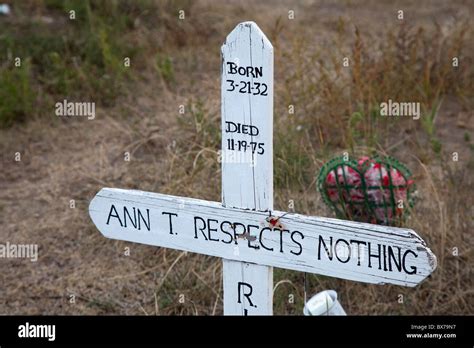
<box><xmin>89</xmin><ymin>188</ymin><xmax>436</xmax><ymax>286</ymax></box>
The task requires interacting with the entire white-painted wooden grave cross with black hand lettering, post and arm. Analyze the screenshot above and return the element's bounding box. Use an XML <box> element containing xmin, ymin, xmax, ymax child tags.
<box><xmin>89</xmin><ymin>22</ymin><xmax>436</xmax><ymax>315</ymax></box>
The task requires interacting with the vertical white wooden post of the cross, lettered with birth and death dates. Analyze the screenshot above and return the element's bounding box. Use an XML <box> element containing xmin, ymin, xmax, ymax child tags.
<box><xmin>221</xmin><ymin>22</ymin><xmax>273</xmax><ymax>315</ymax></box>
